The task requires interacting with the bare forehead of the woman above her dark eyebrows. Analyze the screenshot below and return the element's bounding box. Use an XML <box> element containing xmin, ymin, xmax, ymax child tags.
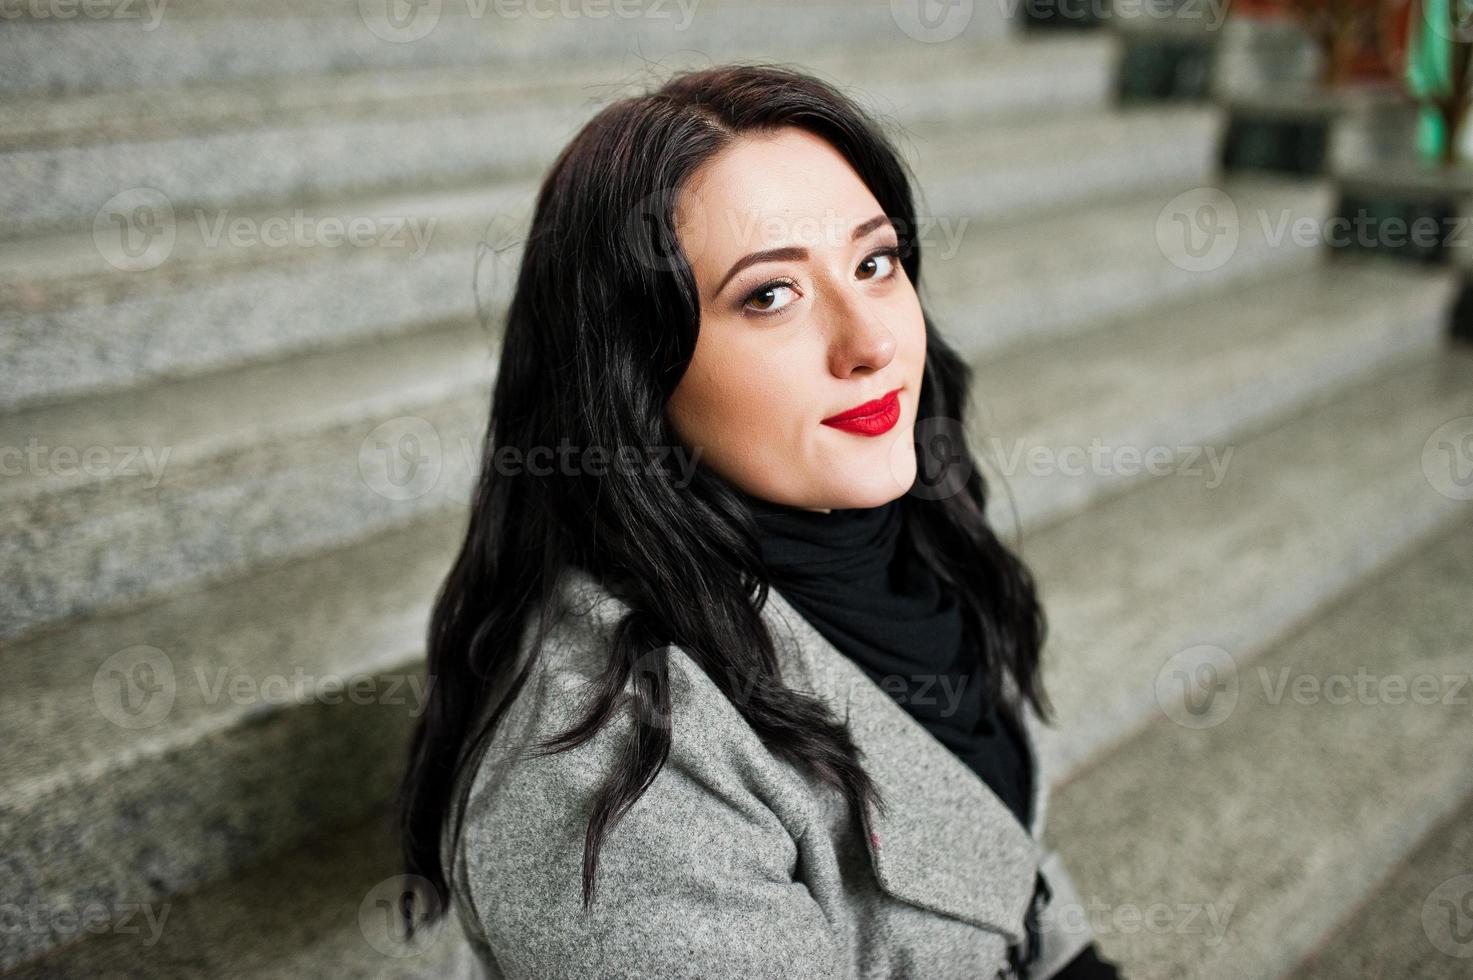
<box><xmin>676</xmin><ymin>127</ymin><xmax>881</xmax><ymax>259</ymax></box>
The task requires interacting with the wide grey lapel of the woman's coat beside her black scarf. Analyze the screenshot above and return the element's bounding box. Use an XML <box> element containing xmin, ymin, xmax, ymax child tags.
<box><xmin>763</xmin><ymin>577</ymin><xmax>1044</xmax><ymax>943</ymax></box>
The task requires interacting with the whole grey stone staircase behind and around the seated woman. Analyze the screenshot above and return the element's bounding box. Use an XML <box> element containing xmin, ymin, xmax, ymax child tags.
<box><xmin>0</xmin><ymin>0</ymin><xmax>1473</xmax><ymax>977</ymax></box>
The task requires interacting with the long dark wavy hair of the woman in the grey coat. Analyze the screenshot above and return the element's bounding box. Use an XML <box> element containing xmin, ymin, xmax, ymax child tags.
<box><xmin>398</xmin><ymin>63</ymin><xmax>1052</xmax><ymax>934</ymax></box>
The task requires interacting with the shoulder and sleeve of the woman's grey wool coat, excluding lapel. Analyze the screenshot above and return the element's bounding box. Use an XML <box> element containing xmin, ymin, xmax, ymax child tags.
<box><xmin>444</xmin><ymin>568</ymin><xmax>838</xmax><ymax>977</ymax></box>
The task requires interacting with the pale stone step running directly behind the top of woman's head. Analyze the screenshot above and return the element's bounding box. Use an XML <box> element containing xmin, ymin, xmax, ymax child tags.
<box><xmin>0</xmin><ymin>34</ymin><xmax>1119</xmax><ymax>150</ymax></box>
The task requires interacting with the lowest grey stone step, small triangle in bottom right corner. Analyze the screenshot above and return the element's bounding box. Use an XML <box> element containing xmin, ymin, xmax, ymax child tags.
<box><xmin>1289</xmin><ymin>789</ymin><xmax>1473</xmax><ymax>980</ymax></box>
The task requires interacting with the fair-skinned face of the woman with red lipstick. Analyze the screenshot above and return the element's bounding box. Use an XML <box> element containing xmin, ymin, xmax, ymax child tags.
<box><xmin>667</xmin><ymin>127</ymin><xmax>925</xmax><ymax>510</ymax></box>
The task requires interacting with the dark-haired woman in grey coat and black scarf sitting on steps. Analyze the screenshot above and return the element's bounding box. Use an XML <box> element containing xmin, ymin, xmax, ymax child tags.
<box><xmin>401</xmin><ymin>65</ymin><xmax>1115</xmax><ymax>979</ymax></box>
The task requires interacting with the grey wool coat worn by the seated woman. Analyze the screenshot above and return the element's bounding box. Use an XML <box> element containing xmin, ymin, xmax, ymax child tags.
<box><xmin>441</xmin><ymin>572</ymin><xmax>1091</xmax><ymax>980</ymax></box>
